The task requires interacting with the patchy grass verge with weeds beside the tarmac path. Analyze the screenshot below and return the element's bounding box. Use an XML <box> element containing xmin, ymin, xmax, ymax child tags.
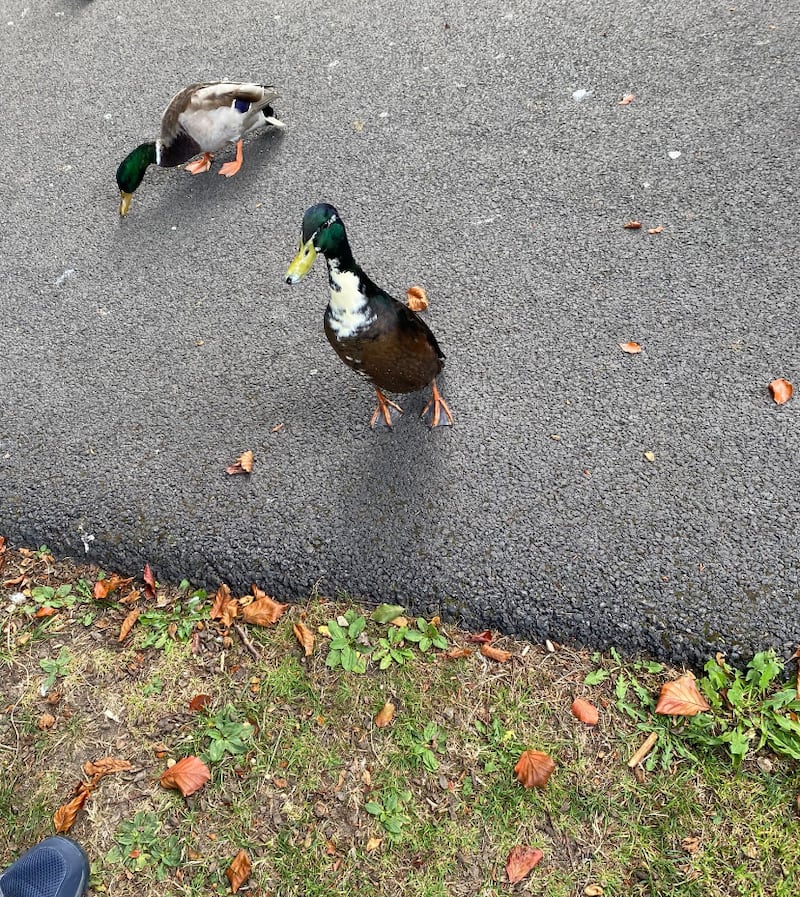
<box><xmin>0</xmin><ymin>549</ymin><xmax>800</xmax><ymax>897</ymax></box>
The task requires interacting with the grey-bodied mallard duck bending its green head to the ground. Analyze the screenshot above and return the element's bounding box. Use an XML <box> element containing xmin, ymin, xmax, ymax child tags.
<box><xmin>117</xmin><ymin>81</ymin><xmax>285</xmax><ymax>215</ymax></box>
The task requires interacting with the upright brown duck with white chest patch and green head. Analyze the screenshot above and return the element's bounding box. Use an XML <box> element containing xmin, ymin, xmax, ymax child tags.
<box><xmin>286</xmin><ymin>203</ymin><xmax>453</xmax><ymax>428</ymax></box>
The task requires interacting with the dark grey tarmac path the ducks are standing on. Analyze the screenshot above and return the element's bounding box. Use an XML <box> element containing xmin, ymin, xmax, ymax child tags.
<box><xmin>0</xmin><ymin>0</ymin><xmax>800</xmax><ymax>663</ymax></box>
